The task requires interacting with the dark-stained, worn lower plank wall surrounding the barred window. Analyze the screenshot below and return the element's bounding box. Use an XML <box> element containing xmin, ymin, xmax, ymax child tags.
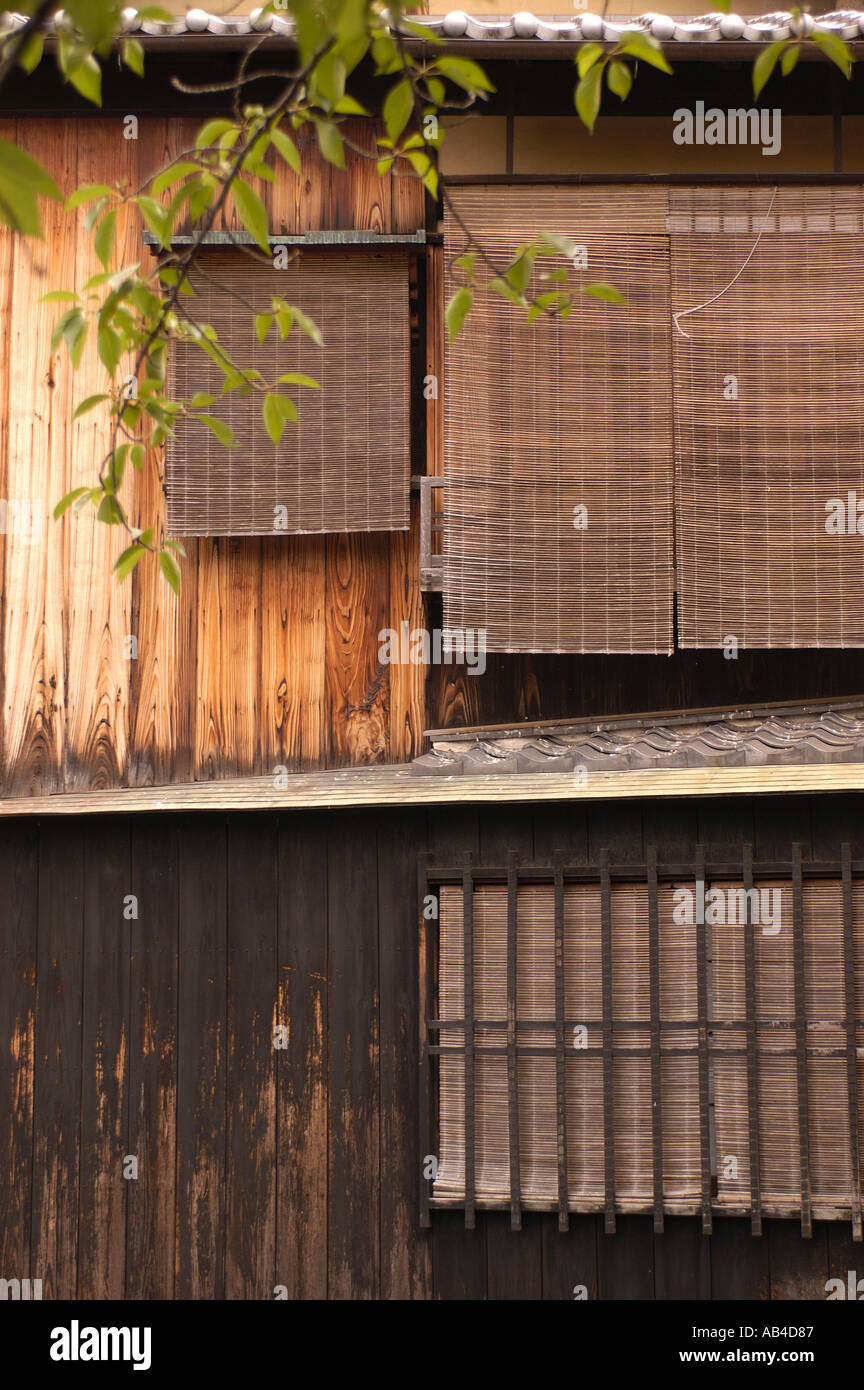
<box><xmin>0</xmin><ymin>796</ymin><xmax>864</xmax><ymax>1300</ymax></box>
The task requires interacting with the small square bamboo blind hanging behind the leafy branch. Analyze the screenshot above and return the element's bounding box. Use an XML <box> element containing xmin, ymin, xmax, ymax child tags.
<box><xmin>167</xmin><ymin>250</ymin><xmax>410</xmax><ymax>535</ymax></box>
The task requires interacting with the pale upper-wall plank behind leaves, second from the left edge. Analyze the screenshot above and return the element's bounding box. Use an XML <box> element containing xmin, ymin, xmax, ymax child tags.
<box><xmin>61</xmin><ymin>118</ymin><xmax>136</xmax><ymax>790</ymax></box>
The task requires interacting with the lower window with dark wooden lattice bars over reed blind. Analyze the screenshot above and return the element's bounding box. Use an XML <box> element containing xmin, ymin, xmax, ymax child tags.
<box><xmin>421</xmin><ymin>847</ymin><xmax>864</xmax><ymax>1238</ymax></box>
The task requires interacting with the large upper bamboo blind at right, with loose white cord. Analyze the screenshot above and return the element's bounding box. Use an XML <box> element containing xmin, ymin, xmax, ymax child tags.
<box><xmin>668</xmin><ymin>188</ymin><xmax>864</xmax><ymax>646</ymax></box>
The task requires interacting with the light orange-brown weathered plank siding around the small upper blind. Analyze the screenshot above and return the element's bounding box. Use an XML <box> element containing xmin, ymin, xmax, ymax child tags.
<box><xmin>0</xmin><ymin>117</ymin><xmax>425</xmax><ymax>796</ymax></box>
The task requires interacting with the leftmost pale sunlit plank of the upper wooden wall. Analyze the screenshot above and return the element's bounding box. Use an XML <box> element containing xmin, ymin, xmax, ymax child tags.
<box><xmin>3</xmin><ymin>118</ymin><xmax>78</xmax><ymax>795</ymax></box>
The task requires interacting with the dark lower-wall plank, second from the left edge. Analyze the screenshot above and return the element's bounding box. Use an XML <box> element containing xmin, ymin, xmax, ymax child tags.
<box><xmin>31</xmin><ymin>820</ymin><xmax>85</xmax><ymax>1298</ymax></box>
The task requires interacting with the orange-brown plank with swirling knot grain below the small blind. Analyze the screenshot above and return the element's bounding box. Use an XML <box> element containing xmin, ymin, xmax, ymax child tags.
<box><xmin>325</xmin><ymin>531</ymin><xmax>391</xmax><ymax>767</ymax></box>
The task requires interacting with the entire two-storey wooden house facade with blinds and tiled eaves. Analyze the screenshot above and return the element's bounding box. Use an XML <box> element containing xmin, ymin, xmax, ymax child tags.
<box><xmin>0</xmin><ymin>6</ymin><xmax>864</xmax><ymax>1300</ymax></box>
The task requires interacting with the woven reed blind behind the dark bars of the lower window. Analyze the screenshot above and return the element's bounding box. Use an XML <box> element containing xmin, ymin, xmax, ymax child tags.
<box><xmin>431</xmin><ymin>865</ymin><xmax>864</xmax><ymax>1225</ymax></box>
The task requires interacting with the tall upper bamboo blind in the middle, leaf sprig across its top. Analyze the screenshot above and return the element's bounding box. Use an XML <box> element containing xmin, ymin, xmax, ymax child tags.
<box><xmin>443</xmin><ymin>188</ymin><xmax>672</xmax><ymax>652</ymax></box>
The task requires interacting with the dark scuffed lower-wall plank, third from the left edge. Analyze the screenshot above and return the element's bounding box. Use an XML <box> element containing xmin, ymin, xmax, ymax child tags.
<box><xmin>78</xmin><ymin>816</ymin><xmax>130</xmax><ymax>1298</ymax></box>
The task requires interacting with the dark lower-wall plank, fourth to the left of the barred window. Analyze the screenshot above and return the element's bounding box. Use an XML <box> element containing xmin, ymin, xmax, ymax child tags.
<box><xmin>225</xmin><ymin>815</ymin><xmax>276</xmax><ymax>1300</ymax></box>
